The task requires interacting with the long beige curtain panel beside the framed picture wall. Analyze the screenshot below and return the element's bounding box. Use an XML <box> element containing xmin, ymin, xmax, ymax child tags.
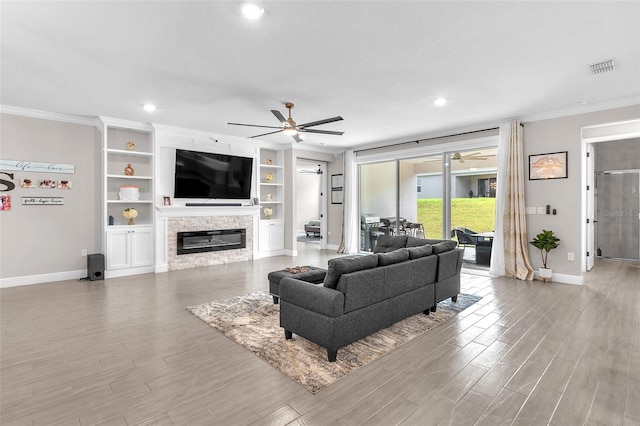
<box><xmin>502</xmin><ymin>121</ymin><xmax>533</xmax><ymax>280</ymax></box>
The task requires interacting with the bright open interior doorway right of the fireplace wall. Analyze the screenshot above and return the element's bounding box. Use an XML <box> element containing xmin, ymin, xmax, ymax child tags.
<box><xmin>295</xmin><ymin>159</ymin><xmax>327</xmax><ymax>250</ymax></box>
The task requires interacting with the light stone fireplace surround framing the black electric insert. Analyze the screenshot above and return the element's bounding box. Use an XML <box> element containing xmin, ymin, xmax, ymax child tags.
<box><xmin>167</xmin><ymin>215</ymin><xmax>254</xmax><ymax>271</ymax></box>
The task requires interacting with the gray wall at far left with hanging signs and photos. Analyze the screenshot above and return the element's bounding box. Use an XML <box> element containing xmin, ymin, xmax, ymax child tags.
<box><xmin>0</xmin><ymin>114</ymin><xmax>101</xmax><ymax>278</ymax></box>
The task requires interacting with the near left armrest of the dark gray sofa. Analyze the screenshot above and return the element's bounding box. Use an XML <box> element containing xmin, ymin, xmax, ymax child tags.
<box><xmin>280</xmin><ymin>277</ymin><xmax>344</xmax><ymax>318</ymax></box>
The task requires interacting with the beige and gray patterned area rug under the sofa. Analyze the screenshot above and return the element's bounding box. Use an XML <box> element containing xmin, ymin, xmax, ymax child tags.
<box><xmin>186</xmin><ymin>291</ymin><xmax>481</xmax><ymax>393</ymax></box>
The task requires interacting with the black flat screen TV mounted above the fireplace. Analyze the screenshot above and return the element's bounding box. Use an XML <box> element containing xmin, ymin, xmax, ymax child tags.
<box><xmin>174</xmin><ymin>149</ymin><xmax>253</xmax><ymax>200</ymax></box>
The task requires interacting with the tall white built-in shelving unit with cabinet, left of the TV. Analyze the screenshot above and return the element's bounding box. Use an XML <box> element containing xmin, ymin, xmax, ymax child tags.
<box><xmin>100</xmin><ymin>118</ymin><xmax>155</xmax><ymax>278</ymax></box>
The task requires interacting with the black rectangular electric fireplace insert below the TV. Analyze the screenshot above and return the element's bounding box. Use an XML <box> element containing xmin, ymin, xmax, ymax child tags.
<box><xmin>178</xmin><ymin>229</ymin><xmax>247</xmax><ymax>254</ymax></box>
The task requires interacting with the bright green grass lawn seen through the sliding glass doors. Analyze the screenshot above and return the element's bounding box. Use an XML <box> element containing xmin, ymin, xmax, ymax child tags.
<box><xmin>418</xmin><ymin>198</ymin><xmax>496</xmax><ymax>238</ymax></box>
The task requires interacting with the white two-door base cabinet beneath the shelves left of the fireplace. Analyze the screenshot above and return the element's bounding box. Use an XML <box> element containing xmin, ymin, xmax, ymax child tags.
<box><xmin>106</xmin><ymin>226</ymin><xmax>154</xmax><ymax>276</ymax></box>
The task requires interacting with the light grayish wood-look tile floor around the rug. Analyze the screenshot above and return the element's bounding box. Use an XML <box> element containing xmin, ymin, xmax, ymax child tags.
<box><xmin>0</xmin><ymin>245</ymin><xmax>640</xmax><ymax>426</ymax></box>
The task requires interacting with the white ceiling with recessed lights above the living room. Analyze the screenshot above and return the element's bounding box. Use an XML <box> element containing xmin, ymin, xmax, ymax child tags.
<box><xmin>0</xmin><ymin>0</ymin><xmax>640</xmax><ymax>149</ymax></box>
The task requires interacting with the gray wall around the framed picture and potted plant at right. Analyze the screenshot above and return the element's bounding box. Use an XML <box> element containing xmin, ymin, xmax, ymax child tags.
<box><xmin>523</xmin><ymin>105</ymin><xmax>640</xmax><ymax>276</ymax></box>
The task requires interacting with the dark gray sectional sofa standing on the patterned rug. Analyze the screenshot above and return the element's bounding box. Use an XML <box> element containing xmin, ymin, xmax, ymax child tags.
<box><xmin>279</xmin><ymin>235</ymin><xmax>463</xmax><ymax>362</ymax></box>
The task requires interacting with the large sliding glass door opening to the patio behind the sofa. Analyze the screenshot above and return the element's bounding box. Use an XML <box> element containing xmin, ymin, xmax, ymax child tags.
<box><xmin>360</xmin><ymin>147</ymin><xmax>497</xmax><ymax>267</ymax></box>
